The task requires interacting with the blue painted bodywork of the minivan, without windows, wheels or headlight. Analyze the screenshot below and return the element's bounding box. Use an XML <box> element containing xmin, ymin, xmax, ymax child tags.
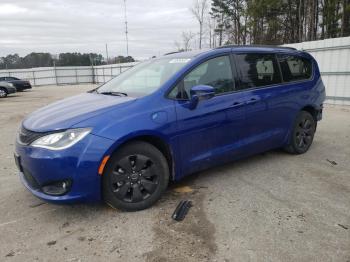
<box><xmin>15</xmin><ymin>47</ymin><xmax>325</xmax><ymax>203</ymax></box>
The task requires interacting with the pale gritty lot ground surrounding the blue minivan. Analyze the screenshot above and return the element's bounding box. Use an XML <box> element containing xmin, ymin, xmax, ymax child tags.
<box><xmin>0</xmin><ymin>85</ymin><xmax>350</xmax><ymax>262</ymax></box>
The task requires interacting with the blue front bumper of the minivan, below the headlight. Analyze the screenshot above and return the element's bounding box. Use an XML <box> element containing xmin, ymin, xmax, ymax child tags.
<box><xmin>15</xmin><ymin>134</ymin><xmax>113</xmax><ymax>203</ymax></box>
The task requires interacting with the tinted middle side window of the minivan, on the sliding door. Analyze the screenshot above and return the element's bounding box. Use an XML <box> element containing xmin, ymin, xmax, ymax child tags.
<box><xmin>236</xmin><ymin>53</ymin><xmax>281</xmax><ymax>89</ymax></box>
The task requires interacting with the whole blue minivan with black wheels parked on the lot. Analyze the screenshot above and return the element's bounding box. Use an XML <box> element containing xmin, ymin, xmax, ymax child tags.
<box><xmin>15</xmin><ymin>46</ymin><xmax>325</xmax><ymax>211</ymax></box>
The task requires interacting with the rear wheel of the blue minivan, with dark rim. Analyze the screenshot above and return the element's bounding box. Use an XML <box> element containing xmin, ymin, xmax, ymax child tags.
<box><xmin>284</xmin><ymin>111</ymin><xmax>316</xmax><ymax>154</ymax></box>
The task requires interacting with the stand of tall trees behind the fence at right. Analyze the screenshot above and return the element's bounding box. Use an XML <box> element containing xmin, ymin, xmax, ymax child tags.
<box><xmin>210</xmin><ymin>0</ymin><xmax>350</xmax><ymax>45</ymax></box>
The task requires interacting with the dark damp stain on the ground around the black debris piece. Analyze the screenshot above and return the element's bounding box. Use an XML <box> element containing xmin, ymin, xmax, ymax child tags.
<box><xmin>144</xmin><ymin>182</ymin><xmax>217</xmax><ymax>262</ymax></box>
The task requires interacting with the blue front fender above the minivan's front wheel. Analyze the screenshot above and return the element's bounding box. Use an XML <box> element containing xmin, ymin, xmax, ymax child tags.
<box><xmin>74</xmin><ymin>98</ymin><xmax>181</xmax><ymax>180</ymax></box>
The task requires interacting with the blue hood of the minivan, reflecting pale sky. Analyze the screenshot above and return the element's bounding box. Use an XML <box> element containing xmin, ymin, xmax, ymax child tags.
<box><xmin>23</xmin><ymin>93</ymin><xmax>136</xmax><ymax>132</ymax></box>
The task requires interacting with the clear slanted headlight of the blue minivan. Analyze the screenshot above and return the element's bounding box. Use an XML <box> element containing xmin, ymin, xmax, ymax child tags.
<box><xmin>31</xmin><ymin>128</ymin><xmax>91</xmax><ymax>150</ymax></box>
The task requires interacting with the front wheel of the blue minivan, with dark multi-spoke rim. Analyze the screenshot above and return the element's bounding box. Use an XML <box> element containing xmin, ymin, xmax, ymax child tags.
<box><xmin>102</xmin><ymin>141</ymin><xmax>169</xmax><ymax>211</ymax></box>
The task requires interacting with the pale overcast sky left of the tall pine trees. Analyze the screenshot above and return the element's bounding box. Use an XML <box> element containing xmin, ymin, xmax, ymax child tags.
<box><xmin>0</xmin><ymin>0</ymin><xmax>198</xmax><ymax>58</ymax></box>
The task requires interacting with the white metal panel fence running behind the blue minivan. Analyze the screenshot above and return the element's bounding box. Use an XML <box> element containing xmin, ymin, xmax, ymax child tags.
<box><xmin>0</xmin><ymin>37</ymin><xmax>350</xmax><ymax>105</ymax></box>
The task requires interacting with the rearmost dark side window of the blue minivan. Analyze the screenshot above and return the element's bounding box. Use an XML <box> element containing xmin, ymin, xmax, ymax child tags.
<box><xmin>278</xmin><ymin>55</ymin><xmax>312</xmax><ymax>82</ymax></box>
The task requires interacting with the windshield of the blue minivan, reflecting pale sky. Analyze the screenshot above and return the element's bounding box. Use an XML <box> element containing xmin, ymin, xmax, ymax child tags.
<box><xmin>96</xmin><ymin>58</ymin><xmax>190</xmax><ymax>96</ymax></box>
